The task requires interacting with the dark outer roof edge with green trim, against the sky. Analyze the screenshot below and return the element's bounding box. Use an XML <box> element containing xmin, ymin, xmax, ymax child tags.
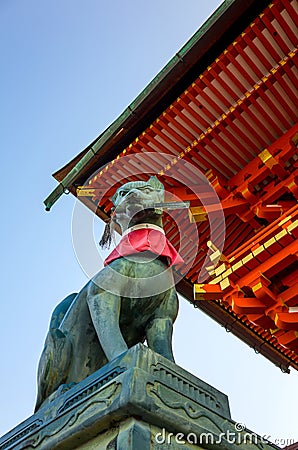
<box><xmin>47</xmin><ymin>0</ymin><xmax>270</xmax><ymax>199</ymax></box>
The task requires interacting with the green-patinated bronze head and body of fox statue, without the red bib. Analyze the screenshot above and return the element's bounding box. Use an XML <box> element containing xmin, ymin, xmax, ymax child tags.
<box><xmin>36</xmin><ymin>177</ymin><xmax>178</xmax><ymax>410</ymax></box>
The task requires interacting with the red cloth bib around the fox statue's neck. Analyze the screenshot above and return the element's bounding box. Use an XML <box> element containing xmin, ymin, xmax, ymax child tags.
<box><xmin>104</xmin><ymin>224</ymin><xmax>184</xmax><ymax>266</ymax></box>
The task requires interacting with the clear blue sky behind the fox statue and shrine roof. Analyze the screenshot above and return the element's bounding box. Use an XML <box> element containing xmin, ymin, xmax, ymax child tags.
<box><xmin>0</xmin><ymin>0</ymin><xmax>298</xmax><ymax>440</ymax></box>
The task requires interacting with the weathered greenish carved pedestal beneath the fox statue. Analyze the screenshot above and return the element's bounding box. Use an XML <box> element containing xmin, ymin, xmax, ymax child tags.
<box><xmin>0</xmin><ymin>344</ymin><xmax>278</xmax><ymax>450</ymax></box>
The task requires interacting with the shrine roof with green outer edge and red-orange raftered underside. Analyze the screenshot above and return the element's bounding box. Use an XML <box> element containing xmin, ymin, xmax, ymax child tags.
<box><xmin>45</xmin><ymin>0</ymin><xmax>298</xmax><ymax>371</ymax></box>
